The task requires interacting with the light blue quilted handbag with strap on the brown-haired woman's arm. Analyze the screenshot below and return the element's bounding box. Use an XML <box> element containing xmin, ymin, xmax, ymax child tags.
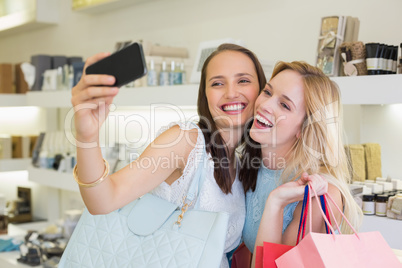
<box><xmin>58</xmin><ymin>146</ymin><xmax>229</xmax><ymax>268</ymax></box>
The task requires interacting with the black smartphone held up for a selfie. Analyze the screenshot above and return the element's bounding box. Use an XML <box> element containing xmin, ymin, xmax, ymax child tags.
<box><xmin>85</xmin><ymin>43</ymin><xmax>147</xmax><ymax>87</ymax></box>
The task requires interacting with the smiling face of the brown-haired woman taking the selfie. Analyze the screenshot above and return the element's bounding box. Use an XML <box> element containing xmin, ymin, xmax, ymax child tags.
<box><xmin>205</xmin><ymin>51</ymin><xmax>259</xmax><ymax>129</ymax></box>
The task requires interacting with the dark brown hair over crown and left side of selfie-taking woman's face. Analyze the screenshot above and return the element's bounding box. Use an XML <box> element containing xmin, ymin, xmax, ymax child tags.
<box><xmin>197</xmin><ymin>44</ymin><xmax>266</xmax><ymax>194</ymax></box>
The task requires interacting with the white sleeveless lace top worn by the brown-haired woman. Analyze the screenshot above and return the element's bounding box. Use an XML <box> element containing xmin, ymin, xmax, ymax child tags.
<box><xmin>152</xmin><ymin>123</ymin><xmax>246</xmax><ymax>268</ymax></box>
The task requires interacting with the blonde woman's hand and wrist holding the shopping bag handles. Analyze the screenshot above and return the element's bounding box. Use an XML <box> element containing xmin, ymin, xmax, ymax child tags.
<box><xmin>267</xmin><ymin>172</ymin><xmax>328</xmax><ymax>208</ymax></box>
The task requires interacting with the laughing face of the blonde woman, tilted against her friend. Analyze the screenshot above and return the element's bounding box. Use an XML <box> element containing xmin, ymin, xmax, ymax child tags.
<box><xmin>250</xmin><ymin>70</ymin><xmax>306</xmax><ymax>153</ymax></box>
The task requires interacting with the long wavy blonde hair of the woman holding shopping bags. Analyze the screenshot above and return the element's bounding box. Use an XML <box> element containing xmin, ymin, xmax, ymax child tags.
<box><xmin>272</xmin><ymin>61</ymin><xmax>363</xmax><ymax>233</ymax></box>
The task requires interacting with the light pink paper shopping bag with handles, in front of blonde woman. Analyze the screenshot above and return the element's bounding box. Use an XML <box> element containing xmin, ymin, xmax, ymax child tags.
<box><xmin>275</xmin><ymin>187</ymin><xmax>402</xmax><ymax>268</ymax></box>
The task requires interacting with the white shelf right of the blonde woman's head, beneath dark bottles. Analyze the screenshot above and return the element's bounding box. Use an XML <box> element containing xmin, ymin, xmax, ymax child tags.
<box><xmin>332</xmin><ymin>74</ymin><xmax>402</xmax><ymax>104</ymax></box>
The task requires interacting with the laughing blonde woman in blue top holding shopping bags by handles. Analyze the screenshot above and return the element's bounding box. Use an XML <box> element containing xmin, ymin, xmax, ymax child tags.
<box><xmin>240</xmin><ymin>62</ymin><xmax>362</xmax><ymax>264</ymax></box>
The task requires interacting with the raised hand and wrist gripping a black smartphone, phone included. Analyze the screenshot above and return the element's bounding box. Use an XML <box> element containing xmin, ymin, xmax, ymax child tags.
<box><xmin>71</xmin><ymin>43</ymin><xmax>146</xmax><ymax>142</ymax></box>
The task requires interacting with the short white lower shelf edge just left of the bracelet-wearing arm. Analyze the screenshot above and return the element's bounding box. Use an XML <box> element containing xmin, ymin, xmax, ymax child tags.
<box><xmin>28</xmin><ymin>166</ymin><xmax>79</xmax><ymax>192</ymax></box>
